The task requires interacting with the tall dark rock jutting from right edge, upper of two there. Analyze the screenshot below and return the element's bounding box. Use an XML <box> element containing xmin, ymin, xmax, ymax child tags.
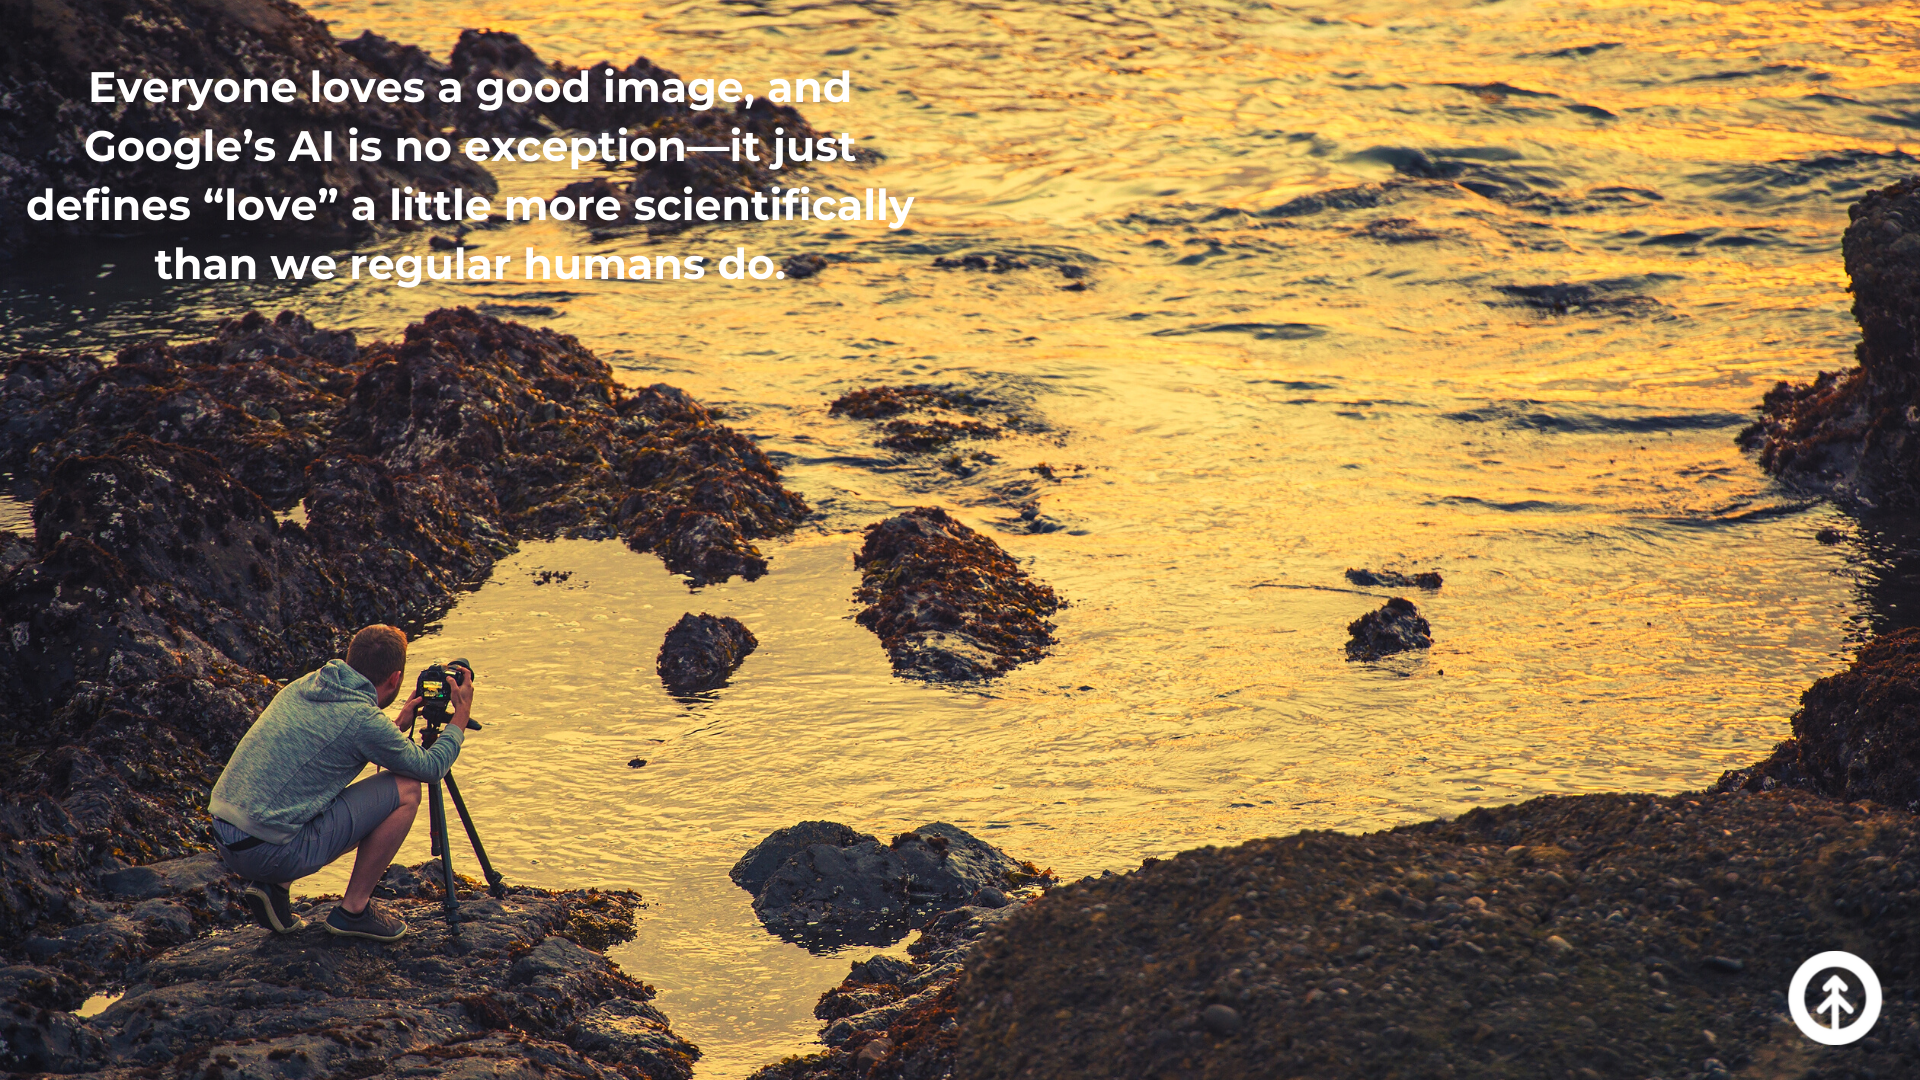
<box><xmin>1741</xmin><ymin>179</ymin><xmax>1920</xmax><ymax>511</ymax></box>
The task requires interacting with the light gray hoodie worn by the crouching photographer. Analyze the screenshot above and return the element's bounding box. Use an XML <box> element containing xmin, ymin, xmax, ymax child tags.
<box><xmin>207</xmin><ymin>659</ymin><xmax>467</xmax><ymax>844</ymax></box>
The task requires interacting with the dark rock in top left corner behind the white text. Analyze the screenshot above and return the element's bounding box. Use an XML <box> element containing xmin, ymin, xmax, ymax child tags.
<box><xmin>0</xmin><ymin>0</ymin><xmax>493</xmax><ymax>258</ymax></box>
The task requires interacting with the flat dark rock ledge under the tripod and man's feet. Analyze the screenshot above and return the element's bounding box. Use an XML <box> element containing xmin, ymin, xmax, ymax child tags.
<box><xmin>0</xmin><ymin>888</ymin><xmax>699</xmax><ymax>1080</ymax></box>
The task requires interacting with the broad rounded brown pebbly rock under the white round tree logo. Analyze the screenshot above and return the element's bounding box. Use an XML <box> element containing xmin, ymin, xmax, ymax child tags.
<box><xmin>948</xmin><ymin>792</ymin><xmax>1920</xmax><ymax>1080</ymax></box>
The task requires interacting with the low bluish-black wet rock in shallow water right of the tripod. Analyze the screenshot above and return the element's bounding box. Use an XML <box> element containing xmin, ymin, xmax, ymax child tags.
<box><xmin>732</xmin><ymin>821</ymin><xmax>1044</xmax><ymax>949</ymax></box>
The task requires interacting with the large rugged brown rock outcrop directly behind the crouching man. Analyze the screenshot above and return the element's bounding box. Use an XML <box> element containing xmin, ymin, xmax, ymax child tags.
<box><xmin>0</xmin><ymin>309</ymin><xmax>806</xmax><ymax>978</ymax></box>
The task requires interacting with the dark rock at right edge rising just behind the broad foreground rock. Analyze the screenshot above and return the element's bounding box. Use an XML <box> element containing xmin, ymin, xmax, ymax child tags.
<box><xmin>1716</xmin><ymin>628</ymin><xmax>1920</xmax><ymax>811</ymax></box>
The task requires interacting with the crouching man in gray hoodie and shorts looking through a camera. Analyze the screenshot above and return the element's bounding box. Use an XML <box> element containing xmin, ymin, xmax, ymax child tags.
<box><xmin>207</xmin><ymin>626</ymin><xmax>474</xmax><ymax>942</ymax></box>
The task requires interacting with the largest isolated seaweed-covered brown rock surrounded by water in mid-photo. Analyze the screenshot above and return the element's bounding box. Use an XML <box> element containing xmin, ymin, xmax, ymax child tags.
<box><xmin>854</xmin><ymin>507</ymin><xmax>1060</xmax><ymax>682</ymax></box>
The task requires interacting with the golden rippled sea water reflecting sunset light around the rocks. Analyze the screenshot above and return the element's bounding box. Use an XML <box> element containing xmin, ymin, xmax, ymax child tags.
<box><xmin>11</xmin><ymin>0</ymin><xmax>1920</xmax><ymax>1078</ymax></box>
